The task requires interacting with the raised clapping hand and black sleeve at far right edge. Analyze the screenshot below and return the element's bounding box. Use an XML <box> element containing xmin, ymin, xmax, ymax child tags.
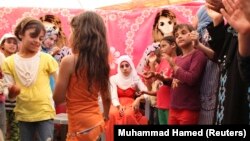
<box><xmin>221</xmin><ymin>1</ymin><xmax>250</xmax><ymax>83</ymax></box>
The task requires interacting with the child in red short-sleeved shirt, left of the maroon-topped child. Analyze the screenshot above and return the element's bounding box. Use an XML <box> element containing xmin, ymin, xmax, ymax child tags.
<box><xmin>144</xmin><ymin>36</ymin><xmax>180</xmax><ymax>124</ymax></box>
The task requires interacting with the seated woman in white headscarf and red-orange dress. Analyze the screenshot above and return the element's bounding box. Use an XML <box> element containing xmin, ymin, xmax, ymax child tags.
<box><xmin>106</xmin><ymin>55</ymin><xmax>148</xmax><ymax>141</ymax></box>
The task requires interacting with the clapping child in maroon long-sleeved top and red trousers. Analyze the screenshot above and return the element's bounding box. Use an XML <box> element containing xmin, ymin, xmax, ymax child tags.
<box><xmin>167</xmin><ymin>24</ymin><xmax>207</xmax><ymax>125</ymax></box>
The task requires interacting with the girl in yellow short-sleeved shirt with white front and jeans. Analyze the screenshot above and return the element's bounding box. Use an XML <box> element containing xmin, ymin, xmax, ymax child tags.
<box><xmin>2</xmin><ymin>17</ymin><xmax>58</xmax><ymax>141</ymax></box>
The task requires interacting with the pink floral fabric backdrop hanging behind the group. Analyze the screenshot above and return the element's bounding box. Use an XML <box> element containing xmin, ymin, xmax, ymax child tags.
<box><xmin>0</xmin><ymin>2</ymin><xmax>202</xmax><ymax>74</ymax></box>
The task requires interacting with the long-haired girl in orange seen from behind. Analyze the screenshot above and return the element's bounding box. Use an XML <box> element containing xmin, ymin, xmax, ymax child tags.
<box><xmin>54</xmin><ymin>11</ymin><xmax>110</xmax><ymax>141</ymax></box>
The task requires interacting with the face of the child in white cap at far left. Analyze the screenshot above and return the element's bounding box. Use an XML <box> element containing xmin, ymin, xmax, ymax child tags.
<box><xmin>3</xmin><ymin>38</ymin><xmax>17</xmax><ymax>54</ymax></box>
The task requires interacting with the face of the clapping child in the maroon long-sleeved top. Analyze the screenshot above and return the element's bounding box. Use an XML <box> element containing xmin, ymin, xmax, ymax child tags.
<box><xmin>174</xmin><ymin>27</ymin><xmax>192</xmax><ymax>48</ymax></box>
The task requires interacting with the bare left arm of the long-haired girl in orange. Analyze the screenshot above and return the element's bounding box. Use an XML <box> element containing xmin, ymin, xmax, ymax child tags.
<box><xmin>53</xmin><ymin>55</ymin><xmax>72</xmax><ymax>104</ymax></box>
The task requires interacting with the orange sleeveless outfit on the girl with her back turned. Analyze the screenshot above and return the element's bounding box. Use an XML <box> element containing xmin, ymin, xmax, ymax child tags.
<box><xmin>66</xmin><ymin>74</ymin><xmax>104</xmax><ymax>141</ymax></box>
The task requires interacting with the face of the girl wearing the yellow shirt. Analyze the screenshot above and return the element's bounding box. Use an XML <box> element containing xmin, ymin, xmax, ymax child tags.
<box><xmin>22</xmin><ymin>28</ymin><xmax>45</xmax><ymax>52</ymax></box>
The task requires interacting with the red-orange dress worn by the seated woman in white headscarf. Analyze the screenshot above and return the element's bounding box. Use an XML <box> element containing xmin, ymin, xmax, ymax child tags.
<box><xmin>105</xmin><ymin>87</ymin><xmax>148</xmax><ymax>141</ymax></box>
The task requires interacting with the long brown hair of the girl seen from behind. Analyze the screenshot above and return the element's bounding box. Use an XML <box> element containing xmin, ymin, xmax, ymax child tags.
<box><xmin>71</xmin><ymin>11</ymin><xmax>110</xmax><ymax>93</ymax></box>
